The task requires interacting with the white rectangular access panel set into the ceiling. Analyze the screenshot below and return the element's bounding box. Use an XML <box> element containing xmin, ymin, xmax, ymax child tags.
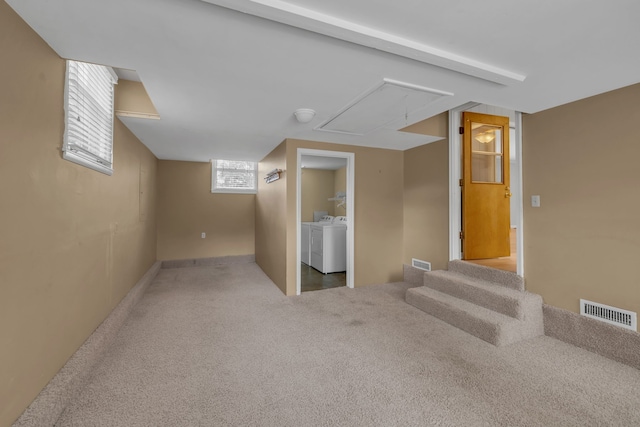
<box><xmin>315</xmin><ymin>79</ymin><xmax>453</xmax><ymax>135</ymax></box>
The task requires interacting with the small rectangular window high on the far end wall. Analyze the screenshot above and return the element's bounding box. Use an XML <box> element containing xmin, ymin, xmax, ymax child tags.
<box><xmin>211</xmin><ymin>160</ymin><xmax>258</xmax><ymax>194</ymax></box>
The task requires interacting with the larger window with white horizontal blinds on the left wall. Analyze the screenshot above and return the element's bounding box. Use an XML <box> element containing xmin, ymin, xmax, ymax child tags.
<box><xmin>62</xmin><ymin>60</ymin><xmax>118</xmax><ymax>175</ymax></box>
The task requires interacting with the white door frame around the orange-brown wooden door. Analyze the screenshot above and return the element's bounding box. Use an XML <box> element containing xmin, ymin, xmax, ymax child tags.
<box><xmin>449</xmin><ymin>102</ymin><xmax>524</xmax><ymax>277</ymax></box>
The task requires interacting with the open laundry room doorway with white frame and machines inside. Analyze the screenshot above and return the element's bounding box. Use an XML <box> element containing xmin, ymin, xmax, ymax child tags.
<box><xmin>296</xmin><ymin>148</ymin><xmax>355</xmax><ymax>295</ymax></box>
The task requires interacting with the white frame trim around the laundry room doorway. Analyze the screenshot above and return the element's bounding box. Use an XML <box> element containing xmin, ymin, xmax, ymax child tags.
<box><xmin>296</xmin><ymin>148</ymin><xmax>356</xmax><ymax>295</ymax></box>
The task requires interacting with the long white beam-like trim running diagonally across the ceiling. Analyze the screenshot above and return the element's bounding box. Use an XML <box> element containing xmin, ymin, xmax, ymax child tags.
<box><xmin>203</xmin><ymin>0</ymin><xmax>527</xmax><ymax>85</ymax></box>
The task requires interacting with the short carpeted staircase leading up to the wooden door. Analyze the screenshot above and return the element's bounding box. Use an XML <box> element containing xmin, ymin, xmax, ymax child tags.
<box><xmin>405</xmin><ymin>261</ymin><xmax>544</xmax><ymax>346</ymax></box>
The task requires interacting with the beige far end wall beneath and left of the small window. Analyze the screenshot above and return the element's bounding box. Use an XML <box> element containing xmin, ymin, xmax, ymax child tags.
<box><xmin>157</xmin><ymin>160</ymin><xmax>256</xmax><ymax>260</ymax></box>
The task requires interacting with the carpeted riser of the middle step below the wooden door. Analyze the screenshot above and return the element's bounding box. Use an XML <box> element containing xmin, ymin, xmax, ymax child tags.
<box><xmin>424</xmin><ymin>273</ymin><xmax>528</xmax><ymax>320</ymax></box>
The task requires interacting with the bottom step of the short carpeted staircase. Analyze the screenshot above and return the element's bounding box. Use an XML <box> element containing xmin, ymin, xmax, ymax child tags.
<box><xmin>406</xmin><ymin>286</ymin><xmax>544</xmax><ymax>346</ymax></box>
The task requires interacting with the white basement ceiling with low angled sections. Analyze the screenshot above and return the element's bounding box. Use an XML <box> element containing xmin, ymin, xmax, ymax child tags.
<box><xmin>6</xmin><ymin>0</ymin><xmax>640</xmax><ymax>161</ymax></box>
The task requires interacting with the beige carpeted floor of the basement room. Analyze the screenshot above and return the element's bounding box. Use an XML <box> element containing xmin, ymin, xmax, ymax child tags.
<box><xmin>57</xmin><ymin>264</ymin><xmax>640</xmax><ymax>427</ymax></box>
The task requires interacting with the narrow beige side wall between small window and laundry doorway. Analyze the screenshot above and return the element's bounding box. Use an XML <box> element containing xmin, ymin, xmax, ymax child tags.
<box><xmin>255</xmin><ymin>141</ymin><xmax>288</xmax><ymax>295</ymax></box>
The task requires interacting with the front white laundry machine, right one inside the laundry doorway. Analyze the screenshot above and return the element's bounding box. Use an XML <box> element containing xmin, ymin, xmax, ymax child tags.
<box><xmin>310</xmin><ymin>216</ymin><xmax>347</xmax><ymax>274</ymax></box>
